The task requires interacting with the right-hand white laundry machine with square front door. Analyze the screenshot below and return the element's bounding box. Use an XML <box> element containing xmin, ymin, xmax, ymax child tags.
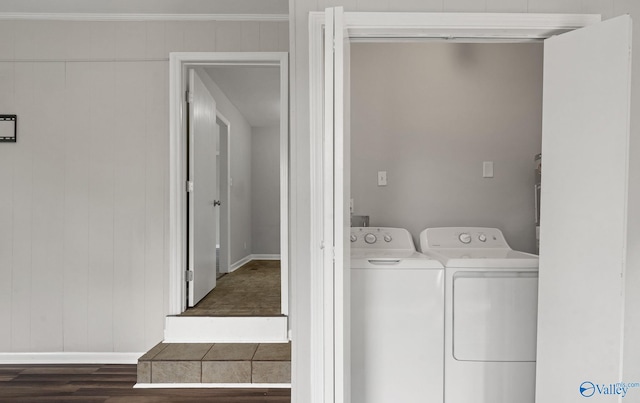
<box><xmin>420</xmin><ymin>227</ymin><xmax>538</xmax><ymax>403</ymax></box>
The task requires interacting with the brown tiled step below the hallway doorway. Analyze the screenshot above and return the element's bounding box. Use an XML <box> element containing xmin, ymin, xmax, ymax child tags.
<box><xmin>138</xmin><ymin>343</ymin><xmax>291</xmax><ymax>386</ymax></box>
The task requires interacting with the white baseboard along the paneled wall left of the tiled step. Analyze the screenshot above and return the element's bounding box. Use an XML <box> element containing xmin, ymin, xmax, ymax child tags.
<box><xmin>0</xmin><ymin>352</ymin><xmax>144</xmax><ymax>365</ymax></box>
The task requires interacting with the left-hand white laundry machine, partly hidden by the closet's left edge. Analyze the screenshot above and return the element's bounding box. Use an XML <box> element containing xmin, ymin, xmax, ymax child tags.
<box><xmin>351</xmin><ymin>227</ymin><xmax>444</xmax><ymax>403</ymax></box>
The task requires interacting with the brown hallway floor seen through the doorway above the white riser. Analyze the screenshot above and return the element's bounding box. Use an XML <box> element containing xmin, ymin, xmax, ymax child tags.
<box><xmin>182</xmin><ymin>260</ymin><xmax>280</xmax><ymax>316</ymax></box>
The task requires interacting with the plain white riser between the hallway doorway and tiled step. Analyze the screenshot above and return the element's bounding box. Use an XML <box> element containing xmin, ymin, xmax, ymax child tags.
<box><xmin>164</xmin><ymin>316</ymin><xmax>289</xmax><ymax>343</ymax></box>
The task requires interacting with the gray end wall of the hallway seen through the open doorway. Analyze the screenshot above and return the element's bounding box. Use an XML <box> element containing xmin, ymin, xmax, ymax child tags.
<box><xmin>251</xmin><ymin>126</ymin><xmax>280</xmax><ymax>255</ymax></box>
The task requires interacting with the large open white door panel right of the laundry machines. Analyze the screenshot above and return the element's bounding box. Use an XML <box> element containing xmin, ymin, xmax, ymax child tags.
<box><xmin>536</xmin><ymin>16</ymin><xmax>631</xmax><ymax>402</ymax></box>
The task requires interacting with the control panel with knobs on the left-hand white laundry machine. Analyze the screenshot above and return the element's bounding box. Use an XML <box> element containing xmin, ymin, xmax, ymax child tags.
<box><xmin>350</xmin><ymin>227</ymin><xmax>416</xmax><ymax>251</ymax></box>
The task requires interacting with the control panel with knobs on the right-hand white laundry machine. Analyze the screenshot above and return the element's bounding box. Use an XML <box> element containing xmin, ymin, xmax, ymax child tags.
<box><xmin>420</xmin><ymin>227</ymin><xmax>509</xmax><ymax>250</ymax></box>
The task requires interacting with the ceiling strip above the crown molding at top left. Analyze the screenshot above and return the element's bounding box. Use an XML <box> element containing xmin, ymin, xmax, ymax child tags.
<box><xmin>0</xmin><ymin>0</ymin><xmax>289</xmax><ymax>15</ymax></box>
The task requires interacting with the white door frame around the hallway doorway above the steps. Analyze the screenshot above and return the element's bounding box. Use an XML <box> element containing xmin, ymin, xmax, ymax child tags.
<box><xmin>168</xmin><ymin>52</ymin><xmax>295</xmax><ymax>316</ymax></box>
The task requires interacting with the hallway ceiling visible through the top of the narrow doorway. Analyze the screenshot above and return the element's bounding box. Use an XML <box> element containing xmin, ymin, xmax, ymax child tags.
<box><xmin>205</xmin><ymin>66</ymin><xmax>280</xmax><ymax>127</ymax></box>
